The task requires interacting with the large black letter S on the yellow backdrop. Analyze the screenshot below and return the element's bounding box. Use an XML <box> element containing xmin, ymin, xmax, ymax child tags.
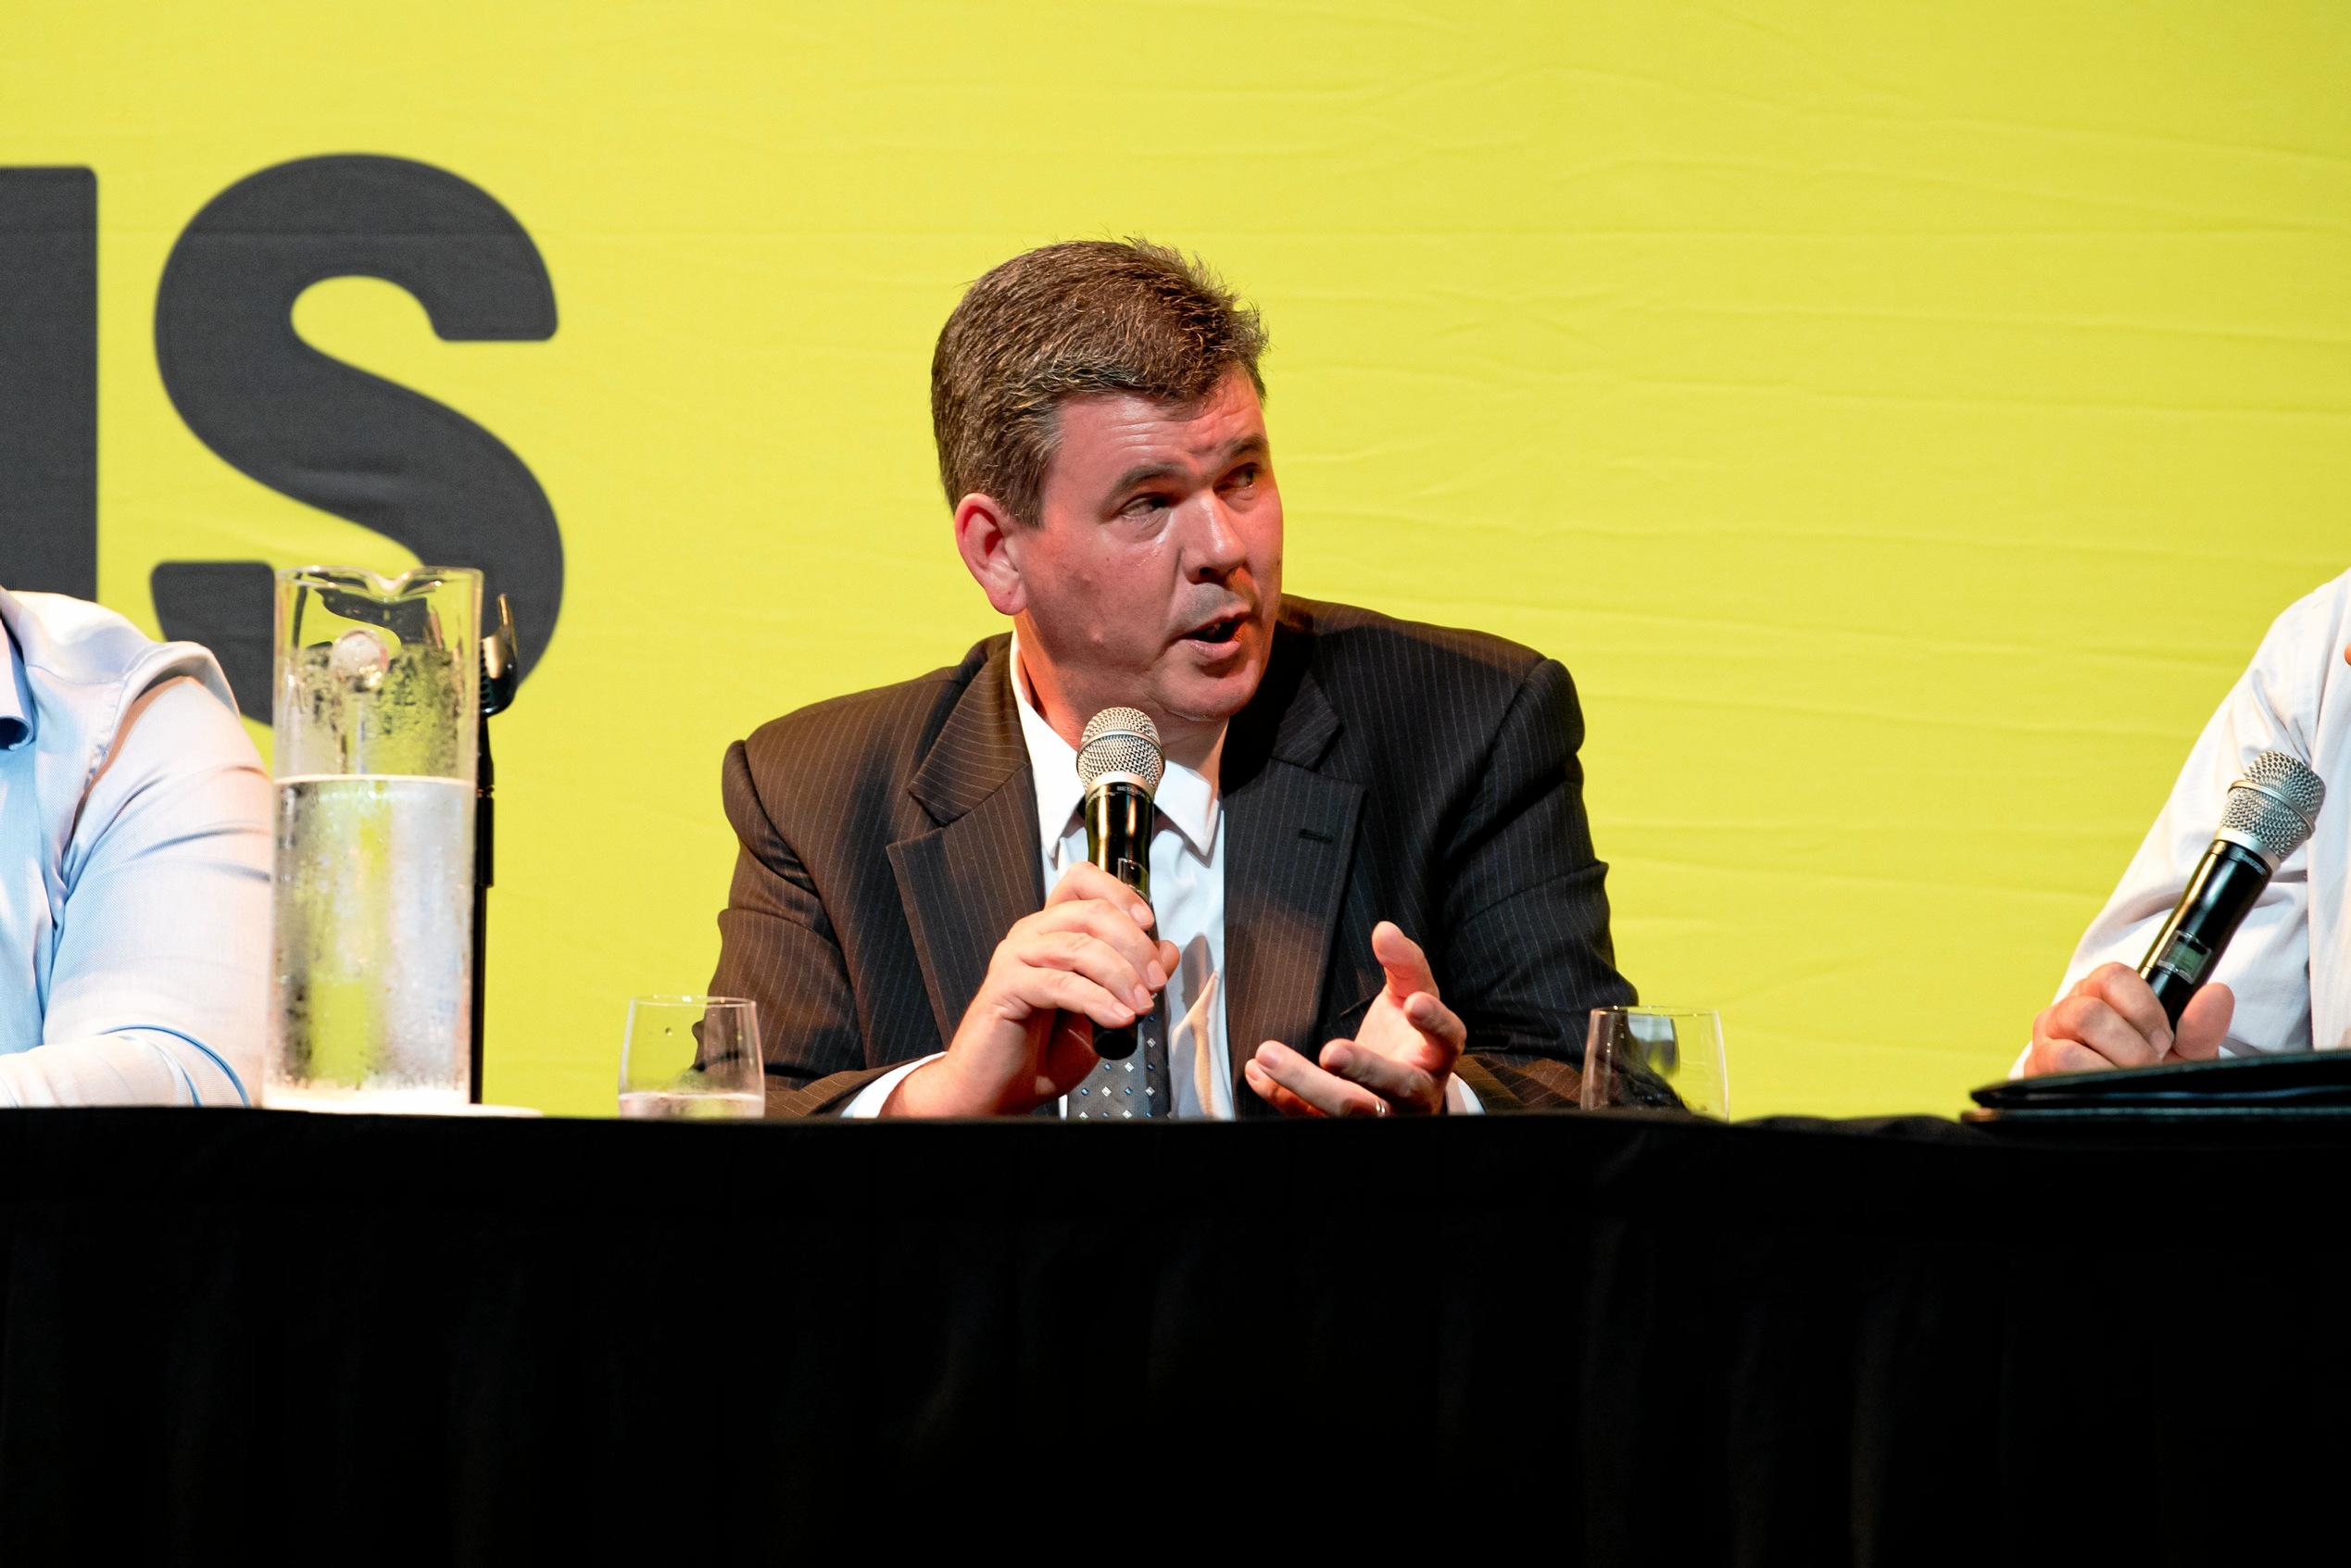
<box><xmin>156</xmin><ymin>156</ymin><xmax>564</xmax><ymax>720</ymax></box>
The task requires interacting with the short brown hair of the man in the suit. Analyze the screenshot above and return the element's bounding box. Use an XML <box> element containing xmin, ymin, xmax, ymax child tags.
<box><xmin>931</xmin><ymin>240</ymin><xmax>1264</xmax><ymax>524</ymax></box>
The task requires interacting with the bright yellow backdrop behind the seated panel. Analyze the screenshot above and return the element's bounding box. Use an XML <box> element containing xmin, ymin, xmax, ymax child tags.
<box><xmin>0</xmin><ymin>0</ymin><xmax>2351</xmax><ymax>1114</ymax></box>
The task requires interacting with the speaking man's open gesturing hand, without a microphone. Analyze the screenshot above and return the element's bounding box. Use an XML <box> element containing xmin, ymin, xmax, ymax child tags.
<box><xmin>1241</xmin><ymin>919</ymin><xmax>1469</xmax><ymax>1117</ymax></box>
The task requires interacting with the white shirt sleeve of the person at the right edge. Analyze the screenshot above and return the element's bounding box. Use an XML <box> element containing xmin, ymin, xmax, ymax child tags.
<box><xmin>2010</xmin><ymin>595</ymin><xmax>2342</xmax><ymax>1077</ymax></box>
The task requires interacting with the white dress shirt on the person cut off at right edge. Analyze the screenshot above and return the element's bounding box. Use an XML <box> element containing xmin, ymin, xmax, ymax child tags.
<box><xmin>2015</xmin><ymin>573</ymin><xmax>2351</xmax><ymax>1072</ymax></box>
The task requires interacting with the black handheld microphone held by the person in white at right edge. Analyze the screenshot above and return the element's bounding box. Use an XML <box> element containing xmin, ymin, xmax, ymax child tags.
<box><xmin>2140</xmin><ymin>752</ymin><xmax>2328</xmax><ymax>1027</ymax></box>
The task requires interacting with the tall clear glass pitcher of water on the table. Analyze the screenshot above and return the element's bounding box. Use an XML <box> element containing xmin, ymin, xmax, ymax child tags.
<box><xmin>261</xmin><ymin>567</ymin><xmax>482</xmax><ymax>1112</ymax></box>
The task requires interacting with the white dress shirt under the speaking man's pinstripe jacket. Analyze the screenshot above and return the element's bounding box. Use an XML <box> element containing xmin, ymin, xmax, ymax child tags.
<box><xmin>842</xmin><ymin>637</ymin><xmax>1483</xmax><ymax>1122</ymax></box>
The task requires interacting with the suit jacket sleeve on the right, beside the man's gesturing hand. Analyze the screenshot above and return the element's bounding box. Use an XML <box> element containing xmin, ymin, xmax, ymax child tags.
<box><xmin>1437</xmin><ymin>659</ymin><xmax>1634</xmax><ymax>1110</ymax></box>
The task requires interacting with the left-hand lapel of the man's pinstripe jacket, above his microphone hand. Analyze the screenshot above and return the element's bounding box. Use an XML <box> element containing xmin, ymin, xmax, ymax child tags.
<box><xmin>888</xmin><ymin>642</ymin><xmax>1044</xmax><ymax>1044</ymax></box>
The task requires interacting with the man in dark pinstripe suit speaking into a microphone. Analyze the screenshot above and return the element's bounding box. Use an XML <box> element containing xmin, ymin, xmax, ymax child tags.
<box><xmin>710</xmin><ymin>242</ymin><xmax>1631</xmax><ymax>1117</ymax></box>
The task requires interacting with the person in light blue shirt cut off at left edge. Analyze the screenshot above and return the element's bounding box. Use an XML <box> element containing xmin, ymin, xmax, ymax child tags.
<box><xmin>0</xmin><ymin>590</ymin><xmax>270</xmax><ymax>1108</ymax></box>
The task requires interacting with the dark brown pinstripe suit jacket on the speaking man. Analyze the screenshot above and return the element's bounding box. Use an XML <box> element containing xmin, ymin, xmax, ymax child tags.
<box><xmin>710</xmin><ymin>597</ymin><xmax>1631</xmax><ymax>1117</ymax></box>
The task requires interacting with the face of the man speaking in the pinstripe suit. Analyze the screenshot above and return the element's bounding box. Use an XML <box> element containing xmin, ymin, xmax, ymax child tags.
<box><xmin>1011</xmin><ymin>371</ymin><xmax>1281</xmax><ymax>759</ymax></box>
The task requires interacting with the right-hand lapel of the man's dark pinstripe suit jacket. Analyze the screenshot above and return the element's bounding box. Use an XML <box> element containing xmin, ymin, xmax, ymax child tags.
<box><xmin>1225</xmin><ymin>623</ymin><xmax>1364</xmax><ymax>1117</ymax></box>
